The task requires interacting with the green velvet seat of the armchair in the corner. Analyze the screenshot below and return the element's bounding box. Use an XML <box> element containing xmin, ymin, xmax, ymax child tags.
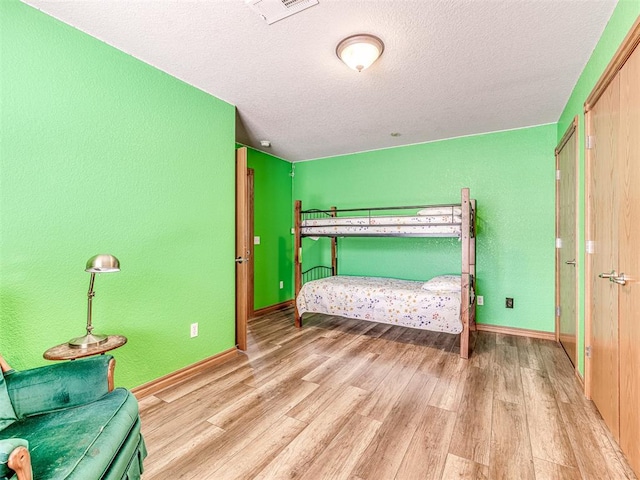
<box><xmin>0</xmin><ymin>388</ymin><xmax>141</xmax><ymax>480</ymax></box>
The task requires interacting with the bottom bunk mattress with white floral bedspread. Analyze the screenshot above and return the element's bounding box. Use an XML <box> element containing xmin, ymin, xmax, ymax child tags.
<box><xmin>296</xmin><ymin>275</ymin><xmax>462</xmax><ymax>333</ymax></box>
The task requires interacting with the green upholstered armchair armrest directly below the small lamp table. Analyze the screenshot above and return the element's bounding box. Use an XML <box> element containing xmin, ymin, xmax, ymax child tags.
<box><xmin>4</xmin><ymin>355</ymin><xmax>115</xmax><ymax>418</ymax></box>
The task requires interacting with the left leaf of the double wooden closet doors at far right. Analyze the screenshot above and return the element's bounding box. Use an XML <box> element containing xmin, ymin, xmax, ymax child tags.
<box><xmin>587</xmin><ymin>75</ymin><xmax>620</xmax><ymax>439</ymax></box>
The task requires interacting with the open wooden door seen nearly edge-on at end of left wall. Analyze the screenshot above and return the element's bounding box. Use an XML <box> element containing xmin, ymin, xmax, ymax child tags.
<box><xmin>235</xmin><ymin>147</ymin><xmax>251</xmax><ymax>350</ymax></box>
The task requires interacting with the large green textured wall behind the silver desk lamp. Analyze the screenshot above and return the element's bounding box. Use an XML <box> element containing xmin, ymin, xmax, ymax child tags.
<box><xmin>0</xmin><ymin>0</ymin><xmax>235</xmax><ymax>386</ymax></box>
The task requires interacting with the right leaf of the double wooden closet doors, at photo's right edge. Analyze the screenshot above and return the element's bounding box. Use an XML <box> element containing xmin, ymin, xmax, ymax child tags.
<box><xmin>617</xmin><ymin>43</ymin><xmax>640</xmax><ymax>474</ymax></box>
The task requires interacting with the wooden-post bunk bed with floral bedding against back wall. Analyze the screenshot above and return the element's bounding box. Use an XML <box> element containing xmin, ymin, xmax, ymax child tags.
<box><xmin>294</xmin><ymin>188</ymin><xmax>476</xmax><ymax>358</ymax></box>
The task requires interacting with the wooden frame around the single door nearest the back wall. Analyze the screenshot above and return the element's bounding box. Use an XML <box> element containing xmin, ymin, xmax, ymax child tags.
<box><xmin>555</xmin><ymin>115</ymin><xmax>580</xmax><ymax>376</ymax></box>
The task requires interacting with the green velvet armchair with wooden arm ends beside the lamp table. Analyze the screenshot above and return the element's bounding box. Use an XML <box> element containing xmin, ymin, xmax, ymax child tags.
<box><xmin>0</xmin><ymin>355</ymin><xmax>147</xmax><ymax>480</ymax></box>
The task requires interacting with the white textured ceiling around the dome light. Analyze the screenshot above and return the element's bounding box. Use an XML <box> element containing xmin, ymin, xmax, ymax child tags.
<box><xmin>25</xmin><ymin>0</ymin><xmax>616</xmax><ymax>161</ymax></box>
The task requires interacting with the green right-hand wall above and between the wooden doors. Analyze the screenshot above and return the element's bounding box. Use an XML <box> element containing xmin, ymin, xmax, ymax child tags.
<box><xmin>557</xmin><ymin>0</ymin><xmax>640</xmax><ymax>374</ymax></box>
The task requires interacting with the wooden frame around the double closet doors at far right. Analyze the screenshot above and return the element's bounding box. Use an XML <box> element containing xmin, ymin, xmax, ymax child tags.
<box><xmin>584</xmin><ymin>16</ymin><xmax>640</xmax><ymax>399</ymax></box>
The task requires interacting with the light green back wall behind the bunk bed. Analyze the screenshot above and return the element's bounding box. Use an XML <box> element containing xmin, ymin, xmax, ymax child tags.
<box><xmin>294</xmin><ymin>124</ymin><xmax>556</xmax><ymax>331</ymax></box>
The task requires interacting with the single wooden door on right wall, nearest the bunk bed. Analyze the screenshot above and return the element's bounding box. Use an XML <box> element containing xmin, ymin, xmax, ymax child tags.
<box><xmin>556</xmin><ymin>117</ymin><xmax>578</xmax><ymax>368</ymax></box>
